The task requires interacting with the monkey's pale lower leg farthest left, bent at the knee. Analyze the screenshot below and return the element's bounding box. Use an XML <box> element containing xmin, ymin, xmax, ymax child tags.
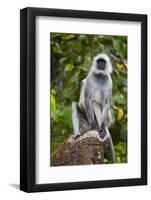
<box><xmin>72</xmin><ymin>102</ymin><xmax>80</xmax><ymax>138</ymax></box>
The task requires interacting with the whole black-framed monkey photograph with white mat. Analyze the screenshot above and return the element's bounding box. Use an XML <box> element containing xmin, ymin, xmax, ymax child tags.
<box><xmin>20</xmin><ymin>8</ymin><xmax>147</xmax><ymax>192</ymax></box>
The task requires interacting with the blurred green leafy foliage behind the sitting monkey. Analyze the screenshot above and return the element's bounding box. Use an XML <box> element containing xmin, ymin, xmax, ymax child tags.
<box><xmin>50</xmin><ymin>33</ymin><xmax>127</xmax><ymax>163</ymax></box>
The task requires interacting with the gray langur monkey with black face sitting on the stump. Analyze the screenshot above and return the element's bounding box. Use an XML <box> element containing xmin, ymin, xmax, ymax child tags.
<box><xmin>72</xmin><ymin>53</ymin><xmax>115</xmax><ymax>162</ymax></box>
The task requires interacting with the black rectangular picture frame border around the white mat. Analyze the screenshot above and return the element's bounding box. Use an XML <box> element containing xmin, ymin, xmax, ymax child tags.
<box><xmin>20</xmin><ymin>7</ymin><xmax>147</xmax><ymax>192</ymax></box>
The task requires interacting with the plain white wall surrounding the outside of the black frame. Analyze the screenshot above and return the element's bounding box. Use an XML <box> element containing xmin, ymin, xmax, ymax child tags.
<box><xmin>0</xmin><ymin>0</ymin><xmax>151</xmax><ymax>200</ymax></box>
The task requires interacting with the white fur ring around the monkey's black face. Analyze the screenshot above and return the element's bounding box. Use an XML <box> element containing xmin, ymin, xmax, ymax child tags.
<box><xmin>91</xmin><ymin>53</ymin><xmax>112</xmax><ymax>74</ymax></box>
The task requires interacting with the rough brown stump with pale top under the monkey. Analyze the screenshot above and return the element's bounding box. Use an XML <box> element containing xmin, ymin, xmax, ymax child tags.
<box><xmin>50</xmin><ymin>131</ymin><xmax>104</xmax><ymax>166</ymax></box>
